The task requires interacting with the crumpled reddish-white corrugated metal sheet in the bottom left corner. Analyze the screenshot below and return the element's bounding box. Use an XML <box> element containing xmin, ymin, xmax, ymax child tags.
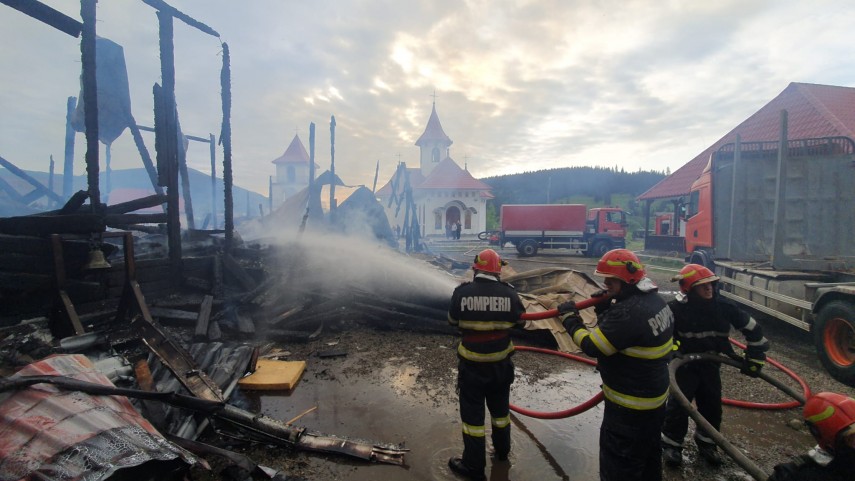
<box><xmin>0</xmin><ymin>354</ymin><xmax>196</xmax><ymax>481</ymax></box>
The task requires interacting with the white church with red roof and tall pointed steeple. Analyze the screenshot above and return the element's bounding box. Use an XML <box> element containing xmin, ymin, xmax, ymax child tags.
<box><xmin>376</xmin><ymin>102</ymin><xmax>493</xmax><ymax>237</ymax></box>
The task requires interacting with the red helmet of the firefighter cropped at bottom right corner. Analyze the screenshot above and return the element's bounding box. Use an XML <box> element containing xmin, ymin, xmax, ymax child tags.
<box><xmin>802</xmin><ymin>392</ymin><xmax>855</xmax><ymax>453</ymax></box>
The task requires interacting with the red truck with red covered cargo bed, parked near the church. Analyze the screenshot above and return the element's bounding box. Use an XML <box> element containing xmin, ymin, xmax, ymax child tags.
<box><xmin>493</xmin><ymin>204</ymin><xmax>628</xmax><ymax>257</ymax></box>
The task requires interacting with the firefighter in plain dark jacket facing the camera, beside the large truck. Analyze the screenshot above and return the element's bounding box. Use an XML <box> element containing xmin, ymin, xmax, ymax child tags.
<box><xmin>662</xmin><ymin>264</ymin><xmax>769</xmax><ymax>466</ymax></box>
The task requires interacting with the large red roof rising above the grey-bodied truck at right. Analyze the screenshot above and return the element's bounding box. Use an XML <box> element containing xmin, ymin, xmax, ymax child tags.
<box><xmin>638</xmin><ymin>82</ymin><xmax>855</xmax><ymax>200</ymax></box>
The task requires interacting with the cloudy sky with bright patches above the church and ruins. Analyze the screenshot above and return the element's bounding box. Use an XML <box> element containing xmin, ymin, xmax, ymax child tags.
<box><xmin>0</xmin><ymin>0</ymin><xmax>855</xmax><ymax>195</ymax></box>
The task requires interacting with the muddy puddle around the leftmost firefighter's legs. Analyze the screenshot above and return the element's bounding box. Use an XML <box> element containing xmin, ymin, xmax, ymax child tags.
<box><xmin>237</xmin><ymin>347</ymin><xmax>602</xmax><ymax>481</ymax></box>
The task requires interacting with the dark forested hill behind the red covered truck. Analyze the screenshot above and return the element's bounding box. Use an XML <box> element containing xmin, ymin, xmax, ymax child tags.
<box><xmin>480</xmin><ymin>167</ymin><xmax>665</xmax><ymax>206</ymax></box>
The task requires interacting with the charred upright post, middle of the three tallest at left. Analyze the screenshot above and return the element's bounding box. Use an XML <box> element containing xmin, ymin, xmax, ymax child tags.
<box><xmin>155</xmin><ymin>11</ymin><xmax>182</xmax><ymax>285</ymax></box>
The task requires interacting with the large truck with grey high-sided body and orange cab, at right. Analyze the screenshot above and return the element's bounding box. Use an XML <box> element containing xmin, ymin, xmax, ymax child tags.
<box><xmin>685</xmin><ymin>118</ymin><xmax>855</xmax><ymax>386</ymax></box>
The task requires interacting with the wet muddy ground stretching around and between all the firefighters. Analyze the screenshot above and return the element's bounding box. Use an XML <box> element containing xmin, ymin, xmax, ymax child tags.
<box><xmin>197</xmin><ymin>248</ymin><xmax>853</xmax><ymax>481</ymax></box>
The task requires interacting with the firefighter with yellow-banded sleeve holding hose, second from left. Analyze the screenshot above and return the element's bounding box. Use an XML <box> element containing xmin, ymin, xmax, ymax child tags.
<box><xmin>558</xmin><ymin>249</ymin><xmax>673</xmax><ymax>481</ymax></box>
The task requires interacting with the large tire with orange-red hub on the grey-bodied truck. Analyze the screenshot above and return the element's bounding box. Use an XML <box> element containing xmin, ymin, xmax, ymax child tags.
<box><xmin>812</xmin><ymin>300</ymin><xmax>855</xmax><ymax>386</ymax></box>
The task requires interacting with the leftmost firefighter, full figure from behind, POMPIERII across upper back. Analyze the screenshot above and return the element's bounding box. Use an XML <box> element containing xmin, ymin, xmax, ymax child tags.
<box><xmin>448</xmin><ymin>249</ymin><xmax>525</xmax><ymax>480</ymax></box>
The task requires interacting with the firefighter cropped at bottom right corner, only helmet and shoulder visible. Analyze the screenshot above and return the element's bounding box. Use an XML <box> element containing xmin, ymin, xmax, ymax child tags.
<box><xmin>768</xmin><ymin>392</ymin><xmax>855</xmax><ymax>481</ymax></box>
